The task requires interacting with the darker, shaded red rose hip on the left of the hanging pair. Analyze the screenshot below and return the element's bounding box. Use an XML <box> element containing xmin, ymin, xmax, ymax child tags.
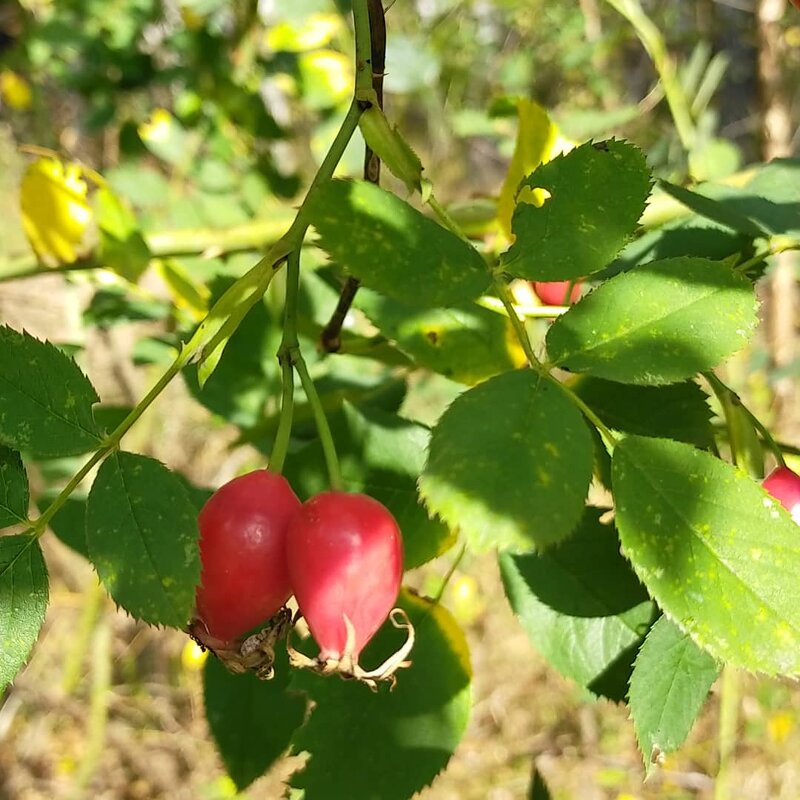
<box><xmin>196</xmin><ymin>469</ymin><xmax>301</xmax><ymax>640</ymax></box>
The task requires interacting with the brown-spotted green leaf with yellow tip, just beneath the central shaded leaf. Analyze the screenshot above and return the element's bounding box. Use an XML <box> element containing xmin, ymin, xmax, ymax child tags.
<box><xmin>357</xmin><ymin>289</ymin><xmax>525</xmax><ymax>385</ymax></box>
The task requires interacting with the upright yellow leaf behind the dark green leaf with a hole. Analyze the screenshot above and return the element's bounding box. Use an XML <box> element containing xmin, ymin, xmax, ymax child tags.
<box><xmin>497</xmin><ymin>98</ymin><xmax>575</xmax><ymax>239</ymax></box>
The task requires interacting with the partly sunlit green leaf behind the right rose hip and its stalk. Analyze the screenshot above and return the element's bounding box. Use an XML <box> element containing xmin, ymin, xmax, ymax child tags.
<box><xmin>284</xmin><ymin>403</ymin><xmax>454</xmax><ymax>569</ymax></box>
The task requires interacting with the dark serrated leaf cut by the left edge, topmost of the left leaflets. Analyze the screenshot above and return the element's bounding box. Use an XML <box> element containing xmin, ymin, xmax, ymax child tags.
<box><xmin>0</xmin><ymin>326</ymin><xmax>100</xmax><ymax>458</ymax></box>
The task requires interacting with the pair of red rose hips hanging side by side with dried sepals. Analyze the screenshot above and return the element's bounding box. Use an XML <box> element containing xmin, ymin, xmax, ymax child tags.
<box><xmin>196</xmin><ymin>470</ymin><xmax>403</xmax><ymax>662</ymax></box>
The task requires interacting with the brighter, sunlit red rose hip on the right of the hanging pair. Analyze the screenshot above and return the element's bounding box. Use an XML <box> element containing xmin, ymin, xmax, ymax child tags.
<box><xmin>286</xmin><ymin>492</ymin><xmax>403</xmax><ymax>662</ymax></box>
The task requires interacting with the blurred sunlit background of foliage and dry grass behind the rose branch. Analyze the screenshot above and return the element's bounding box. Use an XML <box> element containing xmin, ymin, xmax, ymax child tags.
<box><xmin>0</xmin><ymin>0</ymin><xmax>800</xmax><ymax>800</ymax></box>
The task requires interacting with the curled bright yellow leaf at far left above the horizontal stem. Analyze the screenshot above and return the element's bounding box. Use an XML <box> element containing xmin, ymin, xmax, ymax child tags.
<box><xmin>20</xmin><ymin>158</ymin><xmax>92</xmax><ymax>264</ymax></box>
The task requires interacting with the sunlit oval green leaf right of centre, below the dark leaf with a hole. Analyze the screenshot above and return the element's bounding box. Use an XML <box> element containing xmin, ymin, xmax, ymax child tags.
<box><xmin>547</xmin><ymin>258</ymin><xmax>757</xmax><ymax>385</ymax></box>
